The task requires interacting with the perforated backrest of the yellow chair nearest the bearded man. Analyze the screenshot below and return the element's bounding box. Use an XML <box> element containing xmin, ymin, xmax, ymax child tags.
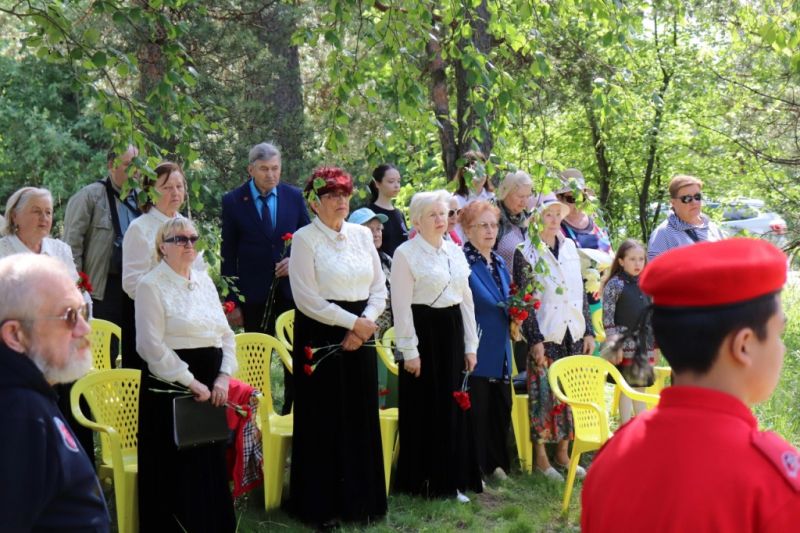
<box><xmin>73</xmin><ymin>368</ymin><xmax>142</xmax><ymax>464</ymax></box>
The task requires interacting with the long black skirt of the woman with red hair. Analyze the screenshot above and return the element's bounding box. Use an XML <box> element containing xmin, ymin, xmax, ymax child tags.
<box><xmin>289</xmin><ymin>301</ymin><xmax>386</xmax><ymax>524</ymax></box>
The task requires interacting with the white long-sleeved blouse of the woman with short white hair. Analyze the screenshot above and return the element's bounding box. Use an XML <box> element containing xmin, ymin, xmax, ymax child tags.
<box><xmin>390</xmin><ymin>235</ymin><xmax>478</xmax><ymax>361</ymax></box>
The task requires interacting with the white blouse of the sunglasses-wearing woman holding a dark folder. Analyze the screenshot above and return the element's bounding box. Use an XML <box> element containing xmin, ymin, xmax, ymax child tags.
<box><xmin>136</xmin><ymin>260</ymin><xmax>238</xmax><ymax>387</ymax></box>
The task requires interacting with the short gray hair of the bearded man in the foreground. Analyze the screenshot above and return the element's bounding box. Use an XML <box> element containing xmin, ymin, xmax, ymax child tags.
<box><xmin>0</xmin><ymin>254</ymin><xmax>71</xmax><ymax>323</ymax></box>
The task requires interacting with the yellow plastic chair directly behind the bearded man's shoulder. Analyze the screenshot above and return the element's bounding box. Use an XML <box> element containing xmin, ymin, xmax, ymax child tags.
<box><xmin>70</xmin><ymin>368</ymin><xmax>141</xmax><ymax>533</ymax></box>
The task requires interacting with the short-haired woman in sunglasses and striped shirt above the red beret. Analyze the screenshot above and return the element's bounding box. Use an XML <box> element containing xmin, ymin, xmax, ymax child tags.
<box><xmin>647</xmin><ymin>175</ymin><xmax>725</xmax><ymax>261</ymax></box>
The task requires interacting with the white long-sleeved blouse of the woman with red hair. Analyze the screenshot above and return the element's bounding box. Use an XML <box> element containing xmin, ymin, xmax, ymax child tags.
<box><xmin>289</xmin><ymin>218</ymin><xmax>388</xmax><ymax>330</ymax></box>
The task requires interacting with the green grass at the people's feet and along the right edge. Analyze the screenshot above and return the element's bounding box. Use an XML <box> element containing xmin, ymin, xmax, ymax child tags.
<box><xmin>231</xmin><ymin>284</ymin><xmax>800</xmax><ymax>533</ymax></box>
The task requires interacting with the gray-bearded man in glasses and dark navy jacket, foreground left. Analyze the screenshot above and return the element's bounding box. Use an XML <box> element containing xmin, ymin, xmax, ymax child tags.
<box><xmin>0</xmin><ymin>254</ymin><xmax>110</xmax><ymax>531</ymax></box>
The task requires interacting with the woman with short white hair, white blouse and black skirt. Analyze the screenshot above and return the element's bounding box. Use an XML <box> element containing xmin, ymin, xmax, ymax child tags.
<box><xmin>391</xmin><ymin>191</ymin><xmax>481</xmax><ymax>502</ymax></box>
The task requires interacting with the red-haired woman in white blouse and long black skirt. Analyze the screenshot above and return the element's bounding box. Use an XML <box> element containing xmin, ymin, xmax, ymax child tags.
<box><xmin>289</xmin><ymin>167</ymin><xmax>387</xmax><ymax>527</ymax></box>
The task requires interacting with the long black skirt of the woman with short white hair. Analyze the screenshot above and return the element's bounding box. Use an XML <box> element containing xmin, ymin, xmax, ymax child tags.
<box><xmin>395</xmin><ymin>305</ymin><xmax>482</xmax><ymax>498</ymax></box>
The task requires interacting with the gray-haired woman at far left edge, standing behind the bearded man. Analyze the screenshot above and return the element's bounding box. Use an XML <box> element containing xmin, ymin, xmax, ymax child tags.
<box><xmin>0</xmin><ymin>187</ymin><xmax>94</xmax><ymax>459</ymax></box>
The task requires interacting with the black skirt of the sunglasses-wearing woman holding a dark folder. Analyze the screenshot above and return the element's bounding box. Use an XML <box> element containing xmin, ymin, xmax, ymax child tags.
<box><xmin>139</xmin><ymin>348</ymin><xmax>236</xmax><ymax>533</ymax></box>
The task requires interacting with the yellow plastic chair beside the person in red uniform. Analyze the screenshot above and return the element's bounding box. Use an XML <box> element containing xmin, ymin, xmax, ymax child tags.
<box><xmin>547</xmin><ymin>355</ymin><xmax>658</xmax><ymax>513</ymax></box>
